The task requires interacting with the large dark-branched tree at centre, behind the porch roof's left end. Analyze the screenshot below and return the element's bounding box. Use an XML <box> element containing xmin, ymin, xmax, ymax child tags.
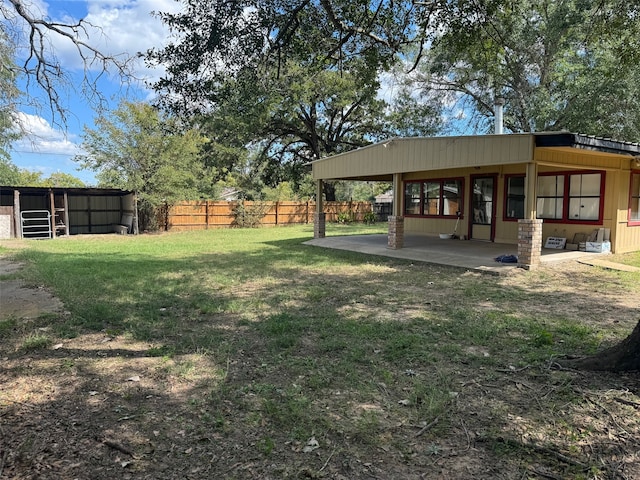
<box><xmin>148</xmin><ymin>1</ymin><xmax>439</xmax><ymax>200</ymax></box>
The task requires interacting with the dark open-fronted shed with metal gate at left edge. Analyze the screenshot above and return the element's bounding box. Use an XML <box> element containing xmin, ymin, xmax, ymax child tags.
<box><xmin>0</xmin><ymin>186</ymin><xmax>138</xmax><ymax>239</ymax></box>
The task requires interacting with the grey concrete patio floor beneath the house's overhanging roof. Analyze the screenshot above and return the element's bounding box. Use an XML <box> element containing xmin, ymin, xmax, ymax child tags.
<box><xmin>305</xmin><ymin>234</ymin><xmax>606</xmax><ymax>274</ymax></box>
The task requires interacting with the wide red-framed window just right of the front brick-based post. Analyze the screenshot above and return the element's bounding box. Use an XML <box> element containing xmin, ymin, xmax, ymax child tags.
<box><xmin>537</xmin><ymin>172</ymin><xmax>604</xmax><ymax>223</ymax></box>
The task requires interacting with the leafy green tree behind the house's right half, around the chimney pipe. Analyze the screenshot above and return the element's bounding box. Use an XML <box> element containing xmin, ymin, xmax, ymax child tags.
<box><xmin>412</xmin><ymin>0</ymin><xmax>639</xmax><ymax>140</ymax></box>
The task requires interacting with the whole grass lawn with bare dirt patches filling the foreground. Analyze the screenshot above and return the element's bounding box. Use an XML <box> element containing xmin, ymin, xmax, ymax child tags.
<box><xmin>0</xmin><ymin>225</ymin><xmax>640</xmax><ymax>479</ymax></box>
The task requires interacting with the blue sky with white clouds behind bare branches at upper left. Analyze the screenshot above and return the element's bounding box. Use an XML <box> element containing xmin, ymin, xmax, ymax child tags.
<box><xmin>11</xmin><ymin>0</ymin><xmax>180</xmax><ymax>186</ymax></box>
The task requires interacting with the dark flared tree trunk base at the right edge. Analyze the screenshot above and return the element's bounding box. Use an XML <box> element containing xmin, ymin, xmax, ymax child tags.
<box><xmin>562</xmin><ymin>321</ymin><xmax>640</xmax><ymax>372</ymax></box>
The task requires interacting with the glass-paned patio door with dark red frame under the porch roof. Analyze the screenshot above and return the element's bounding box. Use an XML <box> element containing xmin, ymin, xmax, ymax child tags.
<box><xmin>469</xmin><ymin>175</ymin><xmax>496</xmax><ymax>242</ymax></box>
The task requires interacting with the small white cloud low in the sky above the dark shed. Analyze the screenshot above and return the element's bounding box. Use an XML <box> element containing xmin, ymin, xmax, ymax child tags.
<box><xmin>13</xmin><ymin>112</ymin><xmax>81</xmax><ymax>156</ymax></box>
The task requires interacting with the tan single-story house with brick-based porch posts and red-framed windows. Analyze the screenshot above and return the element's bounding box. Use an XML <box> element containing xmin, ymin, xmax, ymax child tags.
<box><xmin>312</xmin><ymin>132</ymin><xmax>640</xmax><ymax>267</ymax></box>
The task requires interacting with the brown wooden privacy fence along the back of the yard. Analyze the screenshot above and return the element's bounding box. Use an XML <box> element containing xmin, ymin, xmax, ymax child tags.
<box><xmin>158</xmin><ymin>200</ymin><xmax>373</xmax><ymax>231</ymax></box>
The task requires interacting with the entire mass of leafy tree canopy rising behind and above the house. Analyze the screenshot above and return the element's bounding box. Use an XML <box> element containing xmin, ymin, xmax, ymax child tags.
<box><xmin>146</xmin><ymin>0</ymin><xmax>639</xmax><ymax>201</ymax></box>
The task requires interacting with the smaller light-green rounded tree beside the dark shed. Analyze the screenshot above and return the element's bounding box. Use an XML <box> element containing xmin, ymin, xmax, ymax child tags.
<box><xmin>76</xmin><ymin>102</ymin><xmax>214</xmax><ymax>229</ymax></box>
